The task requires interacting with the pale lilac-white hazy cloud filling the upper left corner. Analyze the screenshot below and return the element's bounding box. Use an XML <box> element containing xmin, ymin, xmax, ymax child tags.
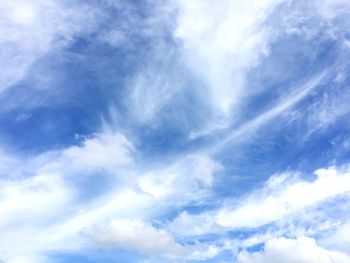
<box><xmin>0</xmin><ymin>0</ymin><xmax>97</xmax><ymax>92</ymax></box>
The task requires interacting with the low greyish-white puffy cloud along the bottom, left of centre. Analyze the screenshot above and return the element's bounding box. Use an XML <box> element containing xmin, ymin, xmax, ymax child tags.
<box><xmin>89</xmin><ymin>219</ymin><xmax>222</xmax><ymax>261</ymax></box>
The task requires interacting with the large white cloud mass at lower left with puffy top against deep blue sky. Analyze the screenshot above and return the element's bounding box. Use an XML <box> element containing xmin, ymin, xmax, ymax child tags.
<box><xmin>0</xmin><ymin>132</ymin><xmax>138</xmax><ymax>263</ymax></box>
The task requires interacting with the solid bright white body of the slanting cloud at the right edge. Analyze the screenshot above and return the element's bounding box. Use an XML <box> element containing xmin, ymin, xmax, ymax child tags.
<box><xmin>215</xmin><ymin>167</ymin><xmax>350</xmax><ymax>228</ymax></box>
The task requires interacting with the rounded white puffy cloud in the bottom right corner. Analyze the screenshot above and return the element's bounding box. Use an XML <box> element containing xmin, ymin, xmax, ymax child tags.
<box><xmin>238</xmin><ymin>237</ymin><xmax>350</xmax><ymax>263</ymax></box>
